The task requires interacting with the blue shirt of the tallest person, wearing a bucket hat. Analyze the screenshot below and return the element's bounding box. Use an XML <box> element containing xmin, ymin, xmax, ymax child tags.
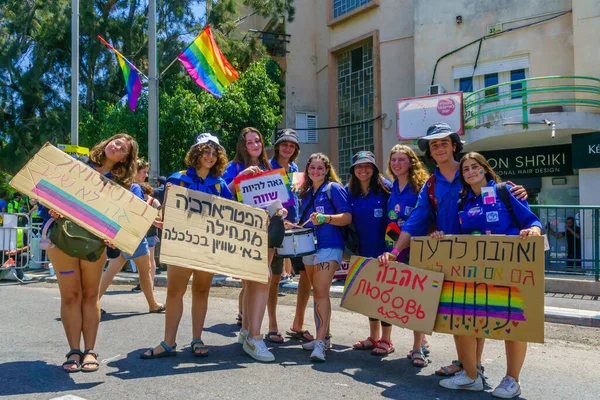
<box><xmin>402</xmin><ymin>167</ymin><xmax>462</xmax><ymax>236</ymax></box>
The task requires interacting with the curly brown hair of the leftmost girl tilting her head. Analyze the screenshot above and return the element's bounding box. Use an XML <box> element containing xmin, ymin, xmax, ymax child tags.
<box><xmin>90</xmin><ymin>133</ymin><xmax>138</xmax><ymax>189</ymax></box>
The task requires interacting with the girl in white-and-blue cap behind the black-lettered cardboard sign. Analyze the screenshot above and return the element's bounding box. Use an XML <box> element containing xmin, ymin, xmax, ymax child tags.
<box><xmin>141</xmin><ymin>133</ymin><xmax>233</xmax><ymax>359</ymax></box>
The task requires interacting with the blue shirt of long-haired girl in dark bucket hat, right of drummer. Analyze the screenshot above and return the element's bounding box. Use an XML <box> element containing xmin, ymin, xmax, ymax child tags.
<box><xmin>346</xmin><ymin>181</ymin><xmax>392</xmax><ymax>257</ymax></box>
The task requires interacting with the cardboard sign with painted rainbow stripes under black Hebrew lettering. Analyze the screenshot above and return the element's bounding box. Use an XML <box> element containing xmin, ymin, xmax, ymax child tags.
<box><xmin>410</xmin><ymin>235</ymin><xmax>544</xmax><ymax>343</ymax></box>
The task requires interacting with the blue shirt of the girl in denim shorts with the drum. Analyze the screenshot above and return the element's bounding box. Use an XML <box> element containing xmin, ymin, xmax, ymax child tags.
<box><xmin>300</xmin><ymin>182</ymin><xmax>352</xmax><ymax>249</ymax></box>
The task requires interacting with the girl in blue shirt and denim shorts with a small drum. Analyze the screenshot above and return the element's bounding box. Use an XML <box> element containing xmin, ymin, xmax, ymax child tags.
<box><xmin>299</xmin><ymin>153</ymin><xmax>352</xmax><ymax>361</ymax></box>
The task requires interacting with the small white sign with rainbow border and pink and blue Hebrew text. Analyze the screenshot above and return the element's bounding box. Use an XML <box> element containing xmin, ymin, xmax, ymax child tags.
<box><xmin>233</xmin><ymin>168</ymin><xmax>294</xmax><ymax>208</ymax></box>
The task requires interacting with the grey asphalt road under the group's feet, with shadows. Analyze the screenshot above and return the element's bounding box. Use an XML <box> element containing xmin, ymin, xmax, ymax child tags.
<box><xmin>0</xmin><ymin>283</ymin><xmax>600</xmax><ymax>399</ymax></box>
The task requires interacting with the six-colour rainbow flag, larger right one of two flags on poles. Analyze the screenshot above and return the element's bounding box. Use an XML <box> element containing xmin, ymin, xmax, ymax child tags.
<box><xmin>177</xmin><ymin>25</ymin><xmax>239</xmax><ymax>97</ymax></box>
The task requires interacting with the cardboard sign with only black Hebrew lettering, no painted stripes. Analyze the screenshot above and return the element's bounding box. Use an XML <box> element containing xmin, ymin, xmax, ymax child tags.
<box><xmin>160</xmin><ymin>186</ymin><xmax>269</xmax><ymax>283</ymax></box>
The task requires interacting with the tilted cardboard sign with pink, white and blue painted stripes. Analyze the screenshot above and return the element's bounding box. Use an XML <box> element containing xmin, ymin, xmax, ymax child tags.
<box><xmin>10</xmin><ymin>143</ymin><xmax>157</xmax><ymax>254</ymax></box>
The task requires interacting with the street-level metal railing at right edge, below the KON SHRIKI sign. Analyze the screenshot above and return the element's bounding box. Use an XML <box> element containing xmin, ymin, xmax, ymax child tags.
<box><xmin>531</xmin><ymin>205</ymin><xmax>600</xmax><ymax>281</ymax></box>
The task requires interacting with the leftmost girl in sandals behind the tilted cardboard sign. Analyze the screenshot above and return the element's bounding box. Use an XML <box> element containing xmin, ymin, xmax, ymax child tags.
<box><xmin>39</xmin><ymin>133</ymin><xmax>138</xmax><ymax>373</ymax></box>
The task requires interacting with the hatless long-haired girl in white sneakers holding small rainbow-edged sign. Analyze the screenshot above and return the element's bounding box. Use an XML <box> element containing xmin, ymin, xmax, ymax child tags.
<box><xmin>223</xmin><ymin>127</ymin><xmax>275</xmax><ymax>362</ymax></box>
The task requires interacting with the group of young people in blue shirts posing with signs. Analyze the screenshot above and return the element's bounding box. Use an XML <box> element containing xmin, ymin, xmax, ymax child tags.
<box><xmin>41</xmin><ymin>123</ymin><xmax>541</xmax><ymax>398</ymax></box>
